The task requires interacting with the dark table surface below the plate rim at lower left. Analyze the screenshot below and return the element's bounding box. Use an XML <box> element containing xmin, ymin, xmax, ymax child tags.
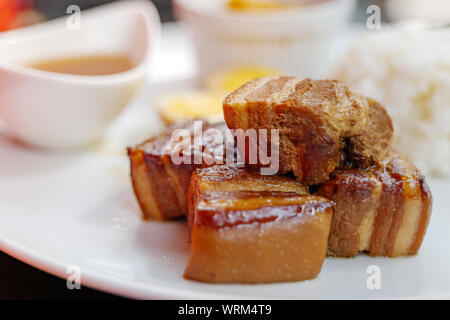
<box><xmin>0</xmin><ymin>251</ymin><xmax>120</xmax><ymax>300</ymax></box>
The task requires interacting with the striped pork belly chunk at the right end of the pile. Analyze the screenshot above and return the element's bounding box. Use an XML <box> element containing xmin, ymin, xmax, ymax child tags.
<box><xmin>316</xmin><ymin>152</ymin><xmax>432</xmax><ymax>257</ymax></box>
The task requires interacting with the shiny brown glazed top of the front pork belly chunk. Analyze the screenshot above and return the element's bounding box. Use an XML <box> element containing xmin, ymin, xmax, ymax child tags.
<box><xmin>188</xmin><ymin>165</ymin><xmax>333</xmax><ymax>229</ymax></box>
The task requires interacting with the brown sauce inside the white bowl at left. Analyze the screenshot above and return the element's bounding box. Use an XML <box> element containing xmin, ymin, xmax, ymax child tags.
<box><xmin>29</xmin><ymin>55</ymin><xmax>135</xmax><ymax>76</ymax></box>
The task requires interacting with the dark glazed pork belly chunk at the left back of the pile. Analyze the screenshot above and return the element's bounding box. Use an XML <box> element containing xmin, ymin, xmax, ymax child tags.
<box><xmin>128</xmin><ymin>120</ymin><xmax>227</xmax><ymax>220</ymax></box>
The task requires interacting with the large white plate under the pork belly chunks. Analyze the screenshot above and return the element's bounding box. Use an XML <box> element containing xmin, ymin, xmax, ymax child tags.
<box><xmin>0</xmin><ymin>82</ymin><xmax>450</xmax><ymax>299</ymax></box>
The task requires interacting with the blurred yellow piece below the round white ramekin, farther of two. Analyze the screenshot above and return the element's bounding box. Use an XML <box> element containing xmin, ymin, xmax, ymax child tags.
<box><xmin>206</xmin><ymin>67</ymin><xmax>280</xmax><ymax>93</ymax></box>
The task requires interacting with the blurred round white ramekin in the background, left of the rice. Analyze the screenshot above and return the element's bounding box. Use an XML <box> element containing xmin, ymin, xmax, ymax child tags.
<box><xmin>173</xmin><ymin>0</ymin><xmax>355</xmax><ymax>77</ymax></box>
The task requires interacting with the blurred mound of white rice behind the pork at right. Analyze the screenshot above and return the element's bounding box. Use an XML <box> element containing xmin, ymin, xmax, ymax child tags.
<box><xmin>331</xmin><ymin>29</ymin><xmax>450</xmax><ymax>177</ymax></box>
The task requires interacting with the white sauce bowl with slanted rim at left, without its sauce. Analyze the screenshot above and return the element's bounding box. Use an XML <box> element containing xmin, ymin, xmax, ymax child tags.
<box><xmin>0</xmin><ymin>1</ymin><xmax>160</xmax><ymax>148</ymax></box>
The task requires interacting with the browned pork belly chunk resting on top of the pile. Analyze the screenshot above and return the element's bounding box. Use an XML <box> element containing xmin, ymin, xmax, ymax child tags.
<box><xmin>223</xmin><ymin>76</ymin><xmax>393</xmax><ymax>185</ymax></box>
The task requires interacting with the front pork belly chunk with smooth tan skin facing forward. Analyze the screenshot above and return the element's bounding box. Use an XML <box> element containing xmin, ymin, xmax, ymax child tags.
<box><xmin>184</xmin><ymin>165</ymin><xmax>333</xmax><ymax>283</ymax></box>
